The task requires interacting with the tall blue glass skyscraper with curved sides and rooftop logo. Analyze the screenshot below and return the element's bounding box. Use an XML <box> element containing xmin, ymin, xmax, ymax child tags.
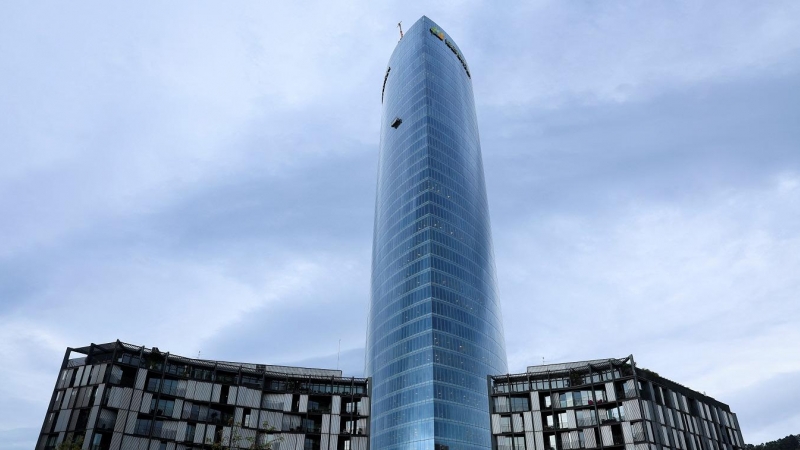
<box><xmin>366</xmin><ymin>17</ymin><xmax>508</xmax><ymax>450</ymax></box>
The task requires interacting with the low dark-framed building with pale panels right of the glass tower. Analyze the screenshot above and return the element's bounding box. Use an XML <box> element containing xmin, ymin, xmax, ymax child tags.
<box><xmin>489</xmin><ymin>355</ymin><xmax>744</xmax><ymax>450</ymax></box>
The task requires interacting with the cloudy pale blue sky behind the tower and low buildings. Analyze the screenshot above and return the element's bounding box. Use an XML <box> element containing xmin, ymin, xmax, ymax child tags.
<box><xmin>0</xmin><ymin>0</ymin><xmax>800</xmax><ymax>449</ymax></box>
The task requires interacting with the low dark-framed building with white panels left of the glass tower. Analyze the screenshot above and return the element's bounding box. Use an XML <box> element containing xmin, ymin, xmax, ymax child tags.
<box><xmin>36</xmin><ymin>341</ymin><xmax>369</xmax><ymax>450</ymax></box>
